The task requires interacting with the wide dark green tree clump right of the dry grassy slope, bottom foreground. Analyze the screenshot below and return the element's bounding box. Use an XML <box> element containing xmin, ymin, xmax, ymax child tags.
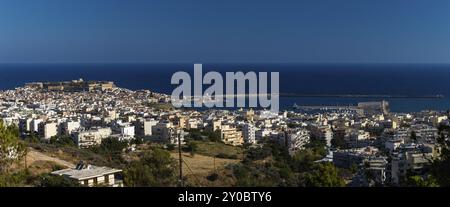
<box><xmin>231</xmin><ymin>141</ymin><xmax>345</xmax><ymax>187</ymax></box>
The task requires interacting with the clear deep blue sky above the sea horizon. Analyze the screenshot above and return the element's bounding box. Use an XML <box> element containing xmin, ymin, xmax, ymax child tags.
<box><xmin>0</xmin><ymin>0</ymin><xmax>450</xmax><ymax>63</ymax></box>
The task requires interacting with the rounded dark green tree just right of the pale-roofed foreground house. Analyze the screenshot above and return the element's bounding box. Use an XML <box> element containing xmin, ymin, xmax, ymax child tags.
<box><xmin>123</xmin><ymin>148</ymin><xmax>177</xmax><ymax>187</ymax></box>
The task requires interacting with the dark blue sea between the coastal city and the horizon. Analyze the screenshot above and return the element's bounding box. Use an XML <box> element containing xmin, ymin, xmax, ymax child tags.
<box><xmin>0</xmin><ymin>64</ymin><xmax>450</xmax><ymax>112</ymax></box>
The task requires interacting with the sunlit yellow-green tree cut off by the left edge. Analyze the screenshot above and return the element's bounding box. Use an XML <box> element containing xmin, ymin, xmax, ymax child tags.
<box><xmin>0</xmin><ymin>121</ymin><xmax>27</xmax><ymax>173</ymax></box>
